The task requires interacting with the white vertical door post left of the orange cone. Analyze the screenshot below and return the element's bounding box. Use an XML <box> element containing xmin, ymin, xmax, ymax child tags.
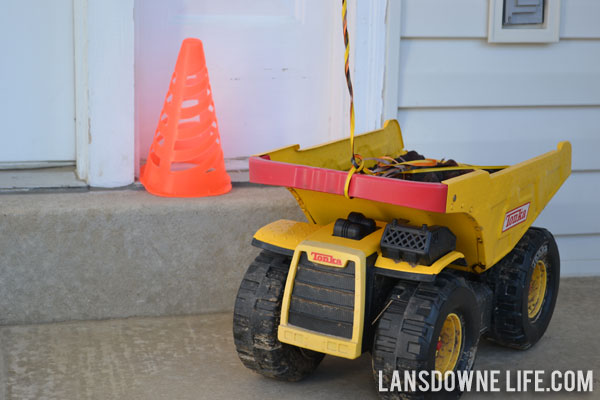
<box><xmin>73</xmin><ymin>0</ymin><xmax>135</xmax><ymax>187</ymax></box>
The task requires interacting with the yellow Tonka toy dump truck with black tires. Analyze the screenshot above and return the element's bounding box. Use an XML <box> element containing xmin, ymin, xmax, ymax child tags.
<box><xmin>233</xmin><ymin>121</ymin><xmax>571</xmax><ymax>398</ymax></box>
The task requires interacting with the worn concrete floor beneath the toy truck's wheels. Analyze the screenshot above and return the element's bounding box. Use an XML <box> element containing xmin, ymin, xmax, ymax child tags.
<box><xmin>0</xmin><ymin>278</ymin><xmax>600</xmax><ymax>400</ymax></box>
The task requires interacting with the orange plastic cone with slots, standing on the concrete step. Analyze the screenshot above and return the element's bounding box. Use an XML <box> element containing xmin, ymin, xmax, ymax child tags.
<box><xmin>140</xmin><ymin>38</ymin><xmax>231</xmax><ymax>197</ymax></box>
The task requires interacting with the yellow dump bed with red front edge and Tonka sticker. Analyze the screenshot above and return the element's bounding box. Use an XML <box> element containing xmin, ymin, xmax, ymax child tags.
<box><xmin>250</xmin><ymin>121</ymin><xmax>571</xmax><ymax>272</ymax></box>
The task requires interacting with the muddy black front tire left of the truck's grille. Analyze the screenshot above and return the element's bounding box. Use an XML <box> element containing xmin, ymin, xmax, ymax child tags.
<box><xmin>233</xmin><ymin>250</ymin><xmax>324</xmax><ymax>381</ymax></box>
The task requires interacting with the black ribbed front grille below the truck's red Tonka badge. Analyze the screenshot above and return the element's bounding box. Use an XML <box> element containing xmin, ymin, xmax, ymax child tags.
<box><xmin>288</xmin><ymin>253</ymin><xmax>355</xmax><ymax>339</ymax></box>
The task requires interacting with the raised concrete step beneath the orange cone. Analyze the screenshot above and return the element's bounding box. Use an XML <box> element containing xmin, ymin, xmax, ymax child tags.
<box><xmin>0</xmin><ymin>186</ymin><xmax>305</xmax><ymax>325</ymax></box>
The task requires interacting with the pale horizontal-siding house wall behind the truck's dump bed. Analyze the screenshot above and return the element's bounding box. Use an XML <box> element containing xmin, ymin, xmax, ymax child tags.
<box><xmin>398</xmin><ymin>0</ymin><xmax>600</xmax><ymax>275</ymax></box>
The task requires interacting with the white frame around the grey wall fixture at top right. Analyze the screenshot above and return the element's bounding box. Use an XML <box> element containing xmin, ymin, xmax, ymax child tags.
<box><xmin>488</xmin><ymin>0</ymin><xmax>560</xmax><ymax>43</ymax></box>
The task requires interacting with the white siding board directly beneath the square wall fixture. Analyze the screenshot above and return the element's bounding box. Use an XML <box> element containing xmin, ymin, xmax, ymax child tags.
<box><xmin>398</xmin><ymin>40</ymin><xmax>600</xmax><ymax>107</ymax></box>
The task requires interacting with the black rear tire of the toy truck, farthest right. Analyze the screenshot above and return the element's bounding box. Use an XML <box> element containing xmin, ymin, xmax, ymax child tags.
<box><xmin>485</xmin><ymin>228</ymin><xmax>560</xmax><ymax>350</ymax></box>
